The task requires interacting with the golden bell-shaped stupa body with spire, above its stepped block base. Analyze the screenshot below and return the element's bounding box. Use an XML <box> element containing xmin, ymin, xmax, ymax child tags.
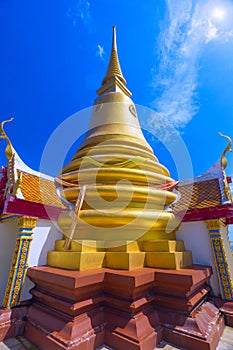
<box><xmin>59</xmin><ymin>26</ymin><xmax>176</xmax><ymax>239</ymax></box>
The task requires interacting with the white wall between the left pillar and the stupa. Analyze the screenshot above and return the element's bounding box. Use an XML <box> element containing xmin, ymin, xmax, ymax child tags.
<box><xmin>21</xmin><ymin>220</ymin><xmax>62</xmax><ymax>300</ymax></box>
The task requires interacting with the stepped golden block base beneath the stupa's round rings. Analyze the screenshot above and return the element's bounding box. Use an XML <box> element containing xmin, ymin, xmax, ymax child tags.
<box><xmin>47</xmin><ymin>240</ymin><xmax>192</xmax><ymax>271</ymax></box>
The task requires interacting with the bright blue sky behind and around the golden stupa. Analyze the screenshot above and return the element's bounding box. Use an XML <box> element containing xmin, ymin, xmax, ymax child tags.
<box><xmin>0</xmin><ymin>0</ymin><xmax>233</xmax><ymax>183</ymax></box>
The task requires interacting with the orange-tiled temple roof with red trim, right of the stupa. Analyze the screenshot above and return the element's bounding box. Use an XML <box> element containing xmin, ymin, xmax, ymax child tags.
<box><xmin>172</xmin><ymin>151</ymin><xmax>233</xmax><ymax>221</ymax></box>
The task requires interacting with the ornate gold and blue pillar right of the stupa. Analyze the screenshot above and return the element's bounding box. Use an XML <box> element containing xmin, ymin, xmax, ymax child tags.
<box><xmin>205</xmin><ymin>219</ymin><xmax>233</xmax><ymax>300</ymax></box>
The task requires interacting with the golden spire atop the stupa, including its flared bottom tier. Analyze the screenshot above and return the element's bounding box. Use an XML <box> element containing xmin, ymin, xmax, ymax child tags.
<box><xmin>97</xmin><ymin>25</ymin><xmax>131</xmax><ymax>96</ymax></box>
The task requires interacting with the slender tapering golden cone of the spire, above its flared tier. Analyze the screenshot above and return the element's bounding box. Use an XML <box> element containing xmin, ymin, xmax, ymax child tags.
<box><xmin>102</xmin><ymin>25</ymin><xmax>126</xmax><ymax>86</ymax></box>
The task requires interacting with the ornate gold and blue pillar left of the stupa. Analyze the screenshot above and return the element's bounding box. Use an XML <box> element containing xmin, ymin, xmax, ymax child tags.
<box><xmin>3</xmin><ymin>216</ymin><xmax>38</xmax><ymax>307</ymax></box>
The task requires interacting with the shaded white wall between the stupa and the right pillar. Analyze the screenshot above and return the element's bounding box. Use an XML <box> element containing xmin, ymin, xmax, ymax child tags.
<box><xmin>176</xmin><ymin>221</ymin><xmax>220</xmax><ymax>296</ymax></box>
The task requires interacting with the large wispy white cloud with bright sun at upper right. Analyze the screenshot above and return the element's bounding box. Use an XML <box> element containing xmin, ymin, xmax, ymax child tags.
<box><xmin>150</xmin><ymin>0</ymin><xmax>233</xmax><ymax>131</ymax></box>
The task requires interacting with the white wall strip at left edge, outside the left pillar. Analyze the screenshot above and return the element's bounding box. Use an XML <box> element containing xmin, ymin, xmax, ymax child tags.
<box><xmin>0</xmin><ymin>220</ymin><xmax>18</xmax><ymax>305</ymax></box>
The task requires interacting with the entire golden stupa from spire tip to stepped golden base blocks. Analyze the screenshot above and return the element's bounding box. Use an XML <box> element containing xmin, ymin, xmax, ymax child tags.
<box><xmin>47</xmin><ymin>26</ymin><xmax>192</xmax><ymax>270</ymax></box>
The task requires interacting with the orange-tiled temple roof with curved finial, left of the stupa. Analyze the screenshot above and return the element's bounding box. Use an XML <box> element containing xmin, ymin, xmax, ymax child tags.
<box><xmin>0</xmin><ymin>119</ymin><xmax>65</xmax><ymax>220</ymax></box>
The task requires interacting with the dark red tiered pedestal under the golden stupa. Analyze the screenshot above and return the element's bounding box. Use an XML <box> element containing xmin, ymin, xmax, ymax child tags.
<box><xmin>20</xmin><ymin>265</ymin><xmax>224</xmax><ymax>350</ymax></box>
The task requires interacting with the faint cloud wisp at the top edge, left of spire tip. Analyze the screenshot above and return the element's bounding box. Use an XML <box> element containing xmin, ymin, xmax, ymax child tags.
<box><xmin>67</xmin><ymin>0</ymin><xmax>91</xmax><ymax>26</ymax></box>
